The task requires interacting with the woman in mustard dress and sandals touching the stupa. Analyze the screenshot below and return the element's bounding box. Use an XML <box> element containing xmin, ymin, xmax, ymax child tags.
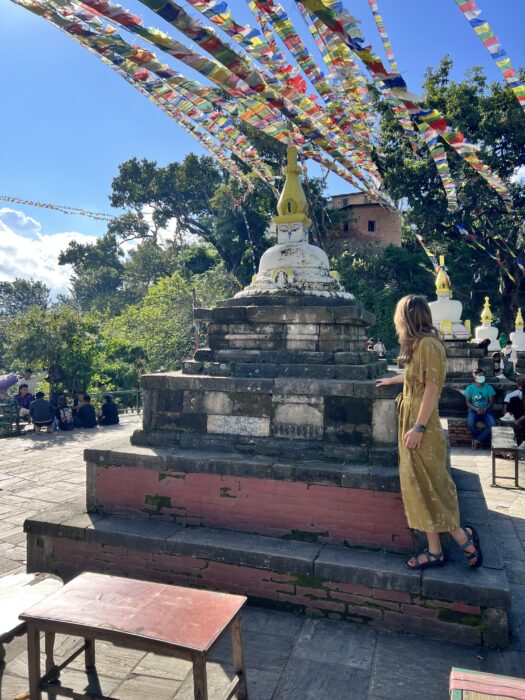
<box><xmin>377</xmin><ymin>295</ymin><xmax>483</xmax><ymax>569</ymax></box>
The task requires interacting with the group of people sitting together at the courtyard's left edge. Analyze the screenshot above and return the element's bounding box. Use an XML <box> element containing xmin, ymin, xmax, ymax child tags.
<box><xmin>4</xmin><ymin>368</ymin><xmax>119</xmax><ymax>434</ymax></box>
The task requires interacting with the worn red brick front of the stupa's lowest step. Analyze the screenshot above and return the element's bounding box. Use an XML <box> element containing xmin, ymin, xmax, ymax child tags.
<box><xmin>37</xmin><ymin>536</ymin><xmax>484</xmax><ymax>645</ymax></box>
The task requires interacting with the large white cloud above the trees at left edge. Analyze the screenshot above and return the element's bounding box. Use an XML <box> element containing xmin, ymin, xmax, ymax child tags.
<box><xmin>0</xmin><ymin>207</ymin><xmax>97</xmax><ymax>296</ymax></box>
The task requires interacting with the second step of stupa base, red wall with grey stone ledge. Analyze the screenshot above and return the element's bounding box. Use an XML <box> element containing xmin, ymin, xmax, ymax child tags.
<box><xmin>85</xmin><ymin>448</ymin><xmax>412</xmax><ymax>552</ymax></box>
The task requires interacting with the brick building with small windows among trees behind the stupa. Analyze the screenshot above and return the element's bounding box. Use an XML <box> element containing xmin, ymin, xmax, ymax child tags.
<box><xmin>329</xmin><ymin>192</ymin><xmax>401</xmax><ymax>254</ymax></box>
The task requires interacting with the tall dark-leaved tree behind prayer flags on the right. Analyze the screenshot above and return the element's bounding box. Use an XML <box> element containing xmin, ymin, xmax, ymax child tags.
<box><xmin>377</xmin><ymin>58</ymin><xmax>525</xmax><ymax>332</ymax></box>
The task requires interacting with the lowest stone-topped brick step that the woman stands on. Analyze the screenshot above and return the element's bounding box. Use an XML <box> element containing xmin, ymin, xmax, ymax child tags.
<box><xmin>24</xmin><ymin>509</ymin><xmax>510</xmax><ymax>647</ymax></box>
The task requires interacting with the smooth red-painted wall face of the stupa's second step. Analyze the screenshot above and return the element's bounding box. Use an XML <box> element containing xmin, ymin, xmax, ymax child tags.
<box><xmin>88</xmin><ymin>464</ymin><xmax>412</xmax><ymax>553</ymax></box>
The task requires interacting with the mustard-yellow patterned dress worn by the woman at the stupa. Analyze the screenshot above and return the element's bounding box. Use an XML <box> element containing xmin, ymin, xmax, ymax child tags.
<box><xmin>398</xmin><ymin>337</ymin><xmax>459</xmax><ymax>532</ymax></box>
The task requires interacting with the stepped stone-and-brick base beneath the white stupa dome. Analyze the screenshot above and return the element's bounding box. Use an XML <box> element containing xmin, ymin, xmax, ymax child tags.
<box><xmin>21</xmin><ymin>295</ymin><xmax>510</xmax><ymax>646</ymax></box>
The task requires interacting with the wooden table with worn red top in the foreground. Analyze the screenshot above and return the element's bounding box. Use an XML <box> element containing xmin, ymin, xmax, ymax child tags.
<box><xmin>20</xmin><ymin>573</ymin><xmax>248</xmax><ymax>700</ymax></box>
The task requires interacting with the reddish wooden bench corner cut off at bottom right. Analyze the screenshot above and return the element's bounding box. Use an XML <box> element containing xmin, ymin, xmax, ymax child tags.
<box><xmin>450</xmin><ymin>668</ymin><xmax>525</xmax><ymax>700</ymax></box>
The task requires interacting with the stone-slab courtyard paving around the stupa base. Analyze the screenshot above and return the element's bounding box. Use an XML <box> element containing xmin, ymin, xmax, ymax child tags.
<box><xmin>0</xmin><ymin>415</ymin><xmax>525</xmax><ymax>700</ymax></box>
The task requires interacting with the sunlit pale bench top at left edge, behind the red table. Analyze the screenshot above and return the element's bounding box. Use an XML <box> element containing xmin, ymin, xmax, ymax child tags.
<box><xmin>0</xmin><ymin>574</ymin><xmax>63</xmax><ymax>663</ymax></box>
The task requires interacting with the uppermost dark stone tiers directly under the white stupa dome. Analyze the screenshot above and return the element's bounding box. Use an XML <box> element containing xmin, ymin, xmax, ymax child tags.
<box><xmin>183</xmin><ymin>297</ymin><xmax>387</xmax><ymax>380</ymax></box>
